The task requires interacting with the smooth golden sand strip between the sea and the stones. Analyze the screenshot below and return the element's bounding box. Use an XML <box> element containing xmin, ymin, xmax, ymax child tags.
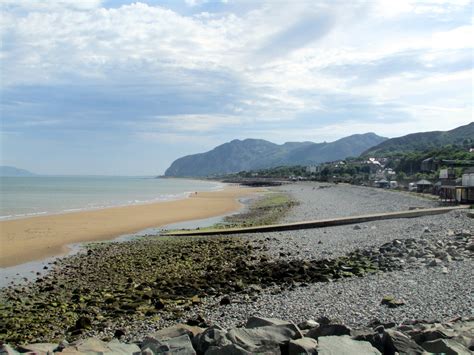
<box><xmin>0</xmin><ymin>186</ymin><xmax>258</xmax><ymax>267</ymax></box>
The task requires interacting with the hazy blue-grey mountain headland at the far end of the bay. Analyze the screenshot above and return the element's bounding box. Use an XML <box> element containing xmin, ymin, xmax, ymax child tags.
<box><xmin>165</xmin><ymin>133</ymin><xmax>387</xmax><ymax>176</ymax></box>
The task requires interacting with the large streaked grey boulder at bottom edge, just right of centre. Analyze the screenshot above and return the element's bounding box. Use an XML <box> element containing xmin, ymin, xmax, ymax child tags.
<box><xmin>227</xmin><ymin>324</ymin><xmax>302</xmax><ymax>353</ymax></box>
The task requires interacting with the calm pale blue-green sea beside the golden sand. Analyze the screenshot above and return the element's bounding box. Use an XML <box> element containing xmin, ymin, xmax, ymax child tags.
<box><xmin>0</xmin><ymin>176</ymin><xmax>222</xmax><ymax>220</ymax></box>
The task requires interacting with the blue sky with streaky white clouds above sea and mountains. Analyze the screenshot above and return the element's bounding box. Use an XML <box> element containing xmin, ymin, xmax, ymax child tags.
<box><xmin>0</xmin><ymin>0</ymin><xmax>474</xmax><ymax>175</ymax></box>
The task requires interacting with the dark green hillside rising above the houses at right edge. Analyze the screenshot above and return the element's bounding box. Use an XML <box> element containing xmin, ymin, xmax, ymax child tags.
<box><xmin>362</xmin><ymin>122</ymin><xmax>474</xmax><ymax>156</ymax></box>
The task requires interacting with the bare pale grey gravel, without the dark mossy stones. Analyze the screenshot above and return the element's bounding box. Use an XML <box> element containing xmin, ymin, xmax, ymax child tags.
<box><xmin>193</xmin><ymin>183</ymin><xmax>474</xmax><ymax>328</ymax></box>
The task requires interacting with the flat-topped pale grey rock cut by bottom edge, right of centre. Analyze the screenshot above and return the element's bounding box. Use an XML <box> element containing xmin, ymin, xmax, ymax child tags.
<box><xmin>318</xmin><ymin>335</ymin><xmax>381</xmax><ymax>355</ymax></box>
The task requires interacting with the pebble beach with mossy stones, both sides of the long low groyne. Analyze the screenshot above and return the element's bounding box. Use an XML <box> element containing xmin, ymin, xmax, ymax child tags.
<box><xmin>3</xmin><ymin>182</ymin><xmax>474</xmax><ymax>353</ymax></box>
